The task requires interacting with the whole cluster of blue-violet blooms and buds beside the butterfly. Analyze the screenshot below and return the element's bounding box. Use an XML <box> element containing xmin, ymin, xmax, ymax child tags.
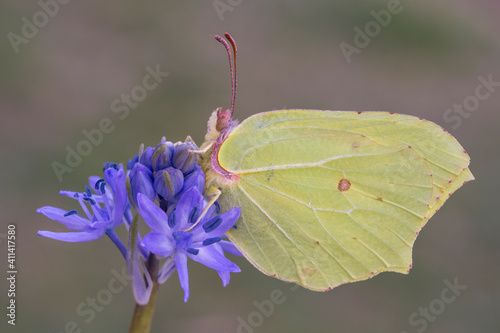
<box><xmin>37</xmin><ymin>138</ymin><xmax>241</xmax><ymax>304</ymax></box>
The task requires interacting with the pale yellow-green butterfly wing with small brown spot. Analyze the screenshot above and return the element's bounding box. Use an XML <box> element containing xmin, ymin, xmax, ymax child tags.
<box><xmin>208</xmin><ymin>110</ymin><xmax>473</xmax><ymax>290</ymax></box>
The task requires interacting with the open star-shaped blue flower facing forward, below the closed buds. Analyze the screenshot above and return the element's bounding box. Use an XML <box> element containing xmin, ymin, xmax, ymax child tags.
<box><xmin>137</xmin><ymin>186</ymin><xmax>241</xmax><ymax>302</ymax></box>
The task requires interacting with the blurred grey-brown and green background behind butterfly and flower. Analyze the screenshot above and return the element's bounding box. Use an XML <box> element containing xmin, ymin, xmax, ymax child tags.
<box><xmin>0</xmin><ymin>0</ymin><xmax>500</xmax><ymax>333</ymax></box>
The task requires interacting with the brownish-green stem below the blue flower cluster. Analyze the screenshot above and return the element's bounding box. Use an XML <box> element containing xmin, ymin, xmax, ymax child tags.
<box><xmin>129</xmin><ymin>254</ymin><xmax>159</xmax><ymax>333</ymax></box>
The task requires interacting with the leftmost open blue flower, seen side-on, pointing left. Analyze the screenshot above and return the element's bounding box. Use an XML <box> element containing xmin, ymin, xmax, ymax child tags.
<box><xmin>37</xmin><ymin>169</ymin><xmax>128</xmax><ymax>256</ymax></box>
